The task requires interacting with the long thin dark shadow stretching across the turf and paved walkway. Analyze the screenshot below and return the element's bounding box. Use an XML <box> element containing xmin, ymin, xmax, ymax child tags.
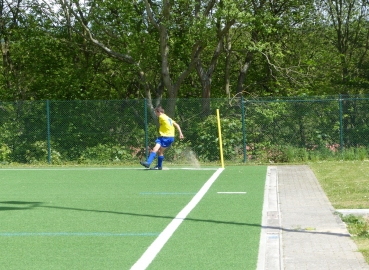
<box><xmin>0</xmin><ymin>201</ymin><xmax>350</xmax><ymax>237</ymax></box>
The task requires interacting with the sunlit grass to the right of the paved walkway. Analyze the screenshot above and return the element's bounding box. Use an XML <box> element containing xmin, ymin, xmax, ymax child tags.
<box><xmin>309</xmin><ymin>160</ymin><xmax>369</xmax><ymax>263</ymax></box>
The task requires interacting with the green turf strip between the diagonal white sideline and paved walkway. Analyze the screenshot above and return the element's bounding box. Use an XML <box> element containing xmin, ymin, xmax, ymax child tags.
<box><xmin>149</xmin><ymin>166</ymin><xmax>266</xmax><ymax>269</ymax></box>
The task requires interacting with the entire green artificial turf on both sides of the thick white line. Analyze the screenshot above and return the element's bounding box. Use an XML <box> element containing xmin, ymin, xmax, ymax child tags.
<box><xmin>0</xmin><ymin>167</ymin><xmax>266</xmax><ymax>270</ymax></box>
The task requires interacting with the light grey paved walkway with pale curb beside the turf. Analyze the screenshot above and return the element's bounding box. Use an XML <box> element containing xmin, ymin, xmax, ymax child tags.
<box><xmin>258</xmin><ymin>166</ymin><xmax>369</xmax><ymax>270</ymax></box>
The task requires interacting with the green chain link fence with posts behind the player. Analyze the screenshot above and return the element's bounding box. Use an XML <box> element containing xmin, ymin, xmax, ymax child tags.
<box><xmin>0</xmin><ymin>95</ymin><xmax>369</xmax><ymax>165</ymax></box>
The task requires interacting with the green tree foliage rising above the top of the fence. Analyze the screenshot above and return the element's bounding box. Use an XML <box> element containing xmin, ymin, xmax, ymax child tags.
<box><xmin>0</xmin><ymin>0</ymin><xmax>369</xmax><ymax>100</ymax></box>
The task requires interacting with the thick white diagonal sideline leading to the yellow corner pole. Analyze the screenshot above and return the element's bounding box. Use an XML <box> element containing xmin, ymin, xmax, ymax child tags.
<box><xmin>131</xmin><ymin>168</ymin><xmax>224</xmax><ymax>270</ymax></box>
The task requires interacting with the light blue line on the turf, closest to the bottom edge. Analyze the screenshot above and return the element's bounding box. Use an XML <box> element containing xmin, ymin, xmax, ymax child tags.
<box><xmin>0</xmin><ymin>232</ymin><xmax>159</xmax><ymax>237</ymax></box>
